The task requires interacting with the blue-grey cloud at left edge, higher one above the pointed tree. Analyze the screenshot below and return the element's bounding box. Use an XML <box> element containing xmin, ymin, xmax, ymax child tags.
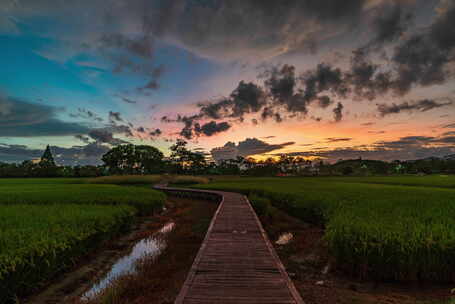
<box><xmin>0</xmin><ymin>96</ymin><xmax>89</xmax><ymax>137</ymax></box>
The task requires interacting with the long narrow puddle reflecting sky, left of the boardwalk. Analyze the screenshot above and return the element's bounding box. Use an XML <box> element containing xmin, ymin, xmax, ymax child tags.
<box><xmin>81</xmin><ymin>222</ymin><xmax>175</xmax><ymax>300</ymax></box>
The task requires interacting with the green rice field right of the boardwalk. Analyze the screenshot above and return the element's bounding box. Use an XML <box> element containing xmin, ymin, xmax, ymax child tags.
<box><xmin>198</xmin><ymin>176</ymin><xmax>455</xmax><ymax>282</ymax></box>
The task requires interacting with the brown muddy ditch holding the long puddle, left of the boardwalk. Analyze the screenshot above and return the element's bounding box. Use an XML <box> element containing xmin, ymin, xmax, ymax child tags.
<box><xmin>25</xmin><ymin>197</ymin><xmax>217</xmax><ymax>304</ymax></box>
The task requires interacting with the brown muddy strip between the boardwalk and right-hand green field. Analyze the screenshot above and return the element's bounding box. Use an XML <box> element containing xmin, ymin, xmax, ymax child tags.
<box><xmin>261</xmin><ymin>208</ymin><xmax>455</xmax><ymax>304</ymax></box>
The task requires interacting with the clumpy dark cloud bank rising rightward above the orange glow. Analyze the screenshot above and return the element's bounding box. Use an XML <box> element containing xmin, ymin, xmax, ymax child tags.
<box><xmin>178</xmin><ymin>64</ymin><xmax>348</xmax><ymax>126</ymax></box>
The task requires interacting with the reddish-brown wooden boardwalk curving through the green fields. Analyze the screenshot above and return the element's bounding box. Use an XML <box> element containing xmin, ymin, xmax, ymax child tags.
<box><xmin>155</xmin><ymin>187</ymin><xmax>303</xmax><ymax>304</ymax></box>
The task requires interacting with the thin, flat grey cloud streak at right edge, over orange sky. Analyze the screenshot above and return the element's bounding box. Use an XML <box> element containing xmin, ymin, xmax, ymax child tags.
<box><xmin>377</xmin><ymin>99</ymin><xmax>453</xmax><ymax>117</ymax></box>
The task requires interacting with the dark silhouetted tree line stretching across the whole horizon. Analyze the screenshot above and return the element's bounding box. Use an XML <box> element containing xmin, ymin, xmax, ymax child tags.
<box><xmin>0</xmin><ymin>140</ymin><xmax>455</xmax><ymax>177</ymax></box>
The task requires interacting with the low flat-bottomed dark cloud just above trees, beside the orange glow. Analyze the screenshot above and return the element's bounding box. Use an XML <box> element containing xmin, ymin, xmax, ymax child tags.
<box><xmin>210</xmin><ymin>138</ymin><xmax>295</xmax><ymax>161</ymax></box>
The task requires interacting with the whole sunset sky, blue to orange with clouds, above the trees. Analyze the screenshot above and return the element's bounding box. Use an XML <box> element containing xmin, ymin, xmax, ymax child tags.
<box><xmin>0</xmin><ymin>0</ymin><xmax>455</xmax><ymax>164</ymax></box>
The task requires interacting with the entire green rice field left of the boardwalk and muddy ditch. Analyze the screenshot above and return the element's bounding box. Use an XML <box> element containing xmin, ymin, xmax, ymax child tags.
<box><xmin>0</xmin><ymin>178</ymin><xmax>166</xmax><ymax>303</ymax></box>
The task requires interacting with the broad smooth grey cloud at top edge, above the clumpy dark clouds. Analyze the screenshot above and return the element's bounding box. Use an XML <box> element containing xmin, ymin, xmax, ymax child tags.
<box><xmin>164</xmin><ymin>0</ymin><xmax>366</xmax><ymax>58</ymax></box>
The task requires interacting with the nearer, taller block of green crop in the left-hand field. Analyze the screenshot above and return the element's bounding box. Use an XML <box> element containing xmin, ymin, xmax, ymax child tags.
<box><xmin>0</xmin><ymin>204</ymin><xmax>136</xmax><ymax>303</ymax></box>
